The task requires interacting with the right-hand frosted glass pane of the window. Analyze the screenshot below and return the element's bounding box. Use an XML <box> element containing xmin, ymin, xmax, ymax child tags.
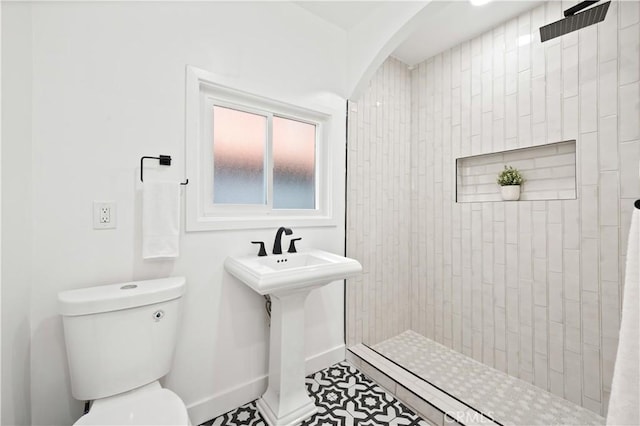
<box><xmin>273</xmin><ymin>117</ymin><xmax>316</xmax><ymax>209</ymax></box>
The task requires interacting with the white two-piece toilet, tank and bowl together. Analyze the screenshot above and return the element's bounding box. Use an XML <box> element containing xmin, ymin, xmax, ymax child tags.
<box><xmin>58</xmin><ymin>277</ymin><xmax>191</xmax><ymax>426</ymax></box>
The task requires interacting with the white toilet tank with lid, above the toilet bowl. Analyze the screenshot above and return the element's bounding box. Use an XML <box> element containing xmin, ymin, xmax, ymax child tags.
<box><xmin>58</xmin><ymin>277</ymin><xmax>186</xmax><ymax>400</ymax></box>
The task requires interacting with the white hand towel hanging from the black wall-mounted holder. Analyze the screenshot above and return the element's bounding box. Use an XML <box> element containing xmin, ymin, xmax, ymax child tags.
<box><xmin>142</xmin><ymin>182</ymin><xmax>180</xmax><ymax>259</ymax></box>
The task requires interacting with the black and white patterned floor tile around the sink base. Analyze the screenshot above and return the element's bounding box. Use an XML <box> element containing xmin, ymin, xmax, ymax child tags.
<box><xmin>201</xmin><ymin>362</ymin><xmax>428</xmax><ymax>426</ymax></box>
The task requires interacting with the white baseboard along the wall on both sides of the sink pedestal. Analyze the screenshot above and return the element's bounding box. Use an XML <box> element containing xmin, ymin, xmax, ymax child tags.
<box><xmin>187</xmin><ymin>344</ymin><xmax>346</xmax><ymax>425</ymax></box>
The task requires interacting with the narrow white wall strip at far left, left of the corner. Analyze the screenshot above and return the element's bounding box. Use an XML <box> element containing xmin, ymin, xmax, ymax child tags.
<box><xmin>0</xmin><ymin>2</ymin><xmax>32</xmax><ymax>425</ymax></box>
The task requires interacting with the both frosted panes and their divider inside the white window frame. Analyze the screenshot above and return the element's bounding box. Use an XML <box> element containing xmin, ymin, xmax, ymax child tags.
<box><xmin>210</xmin><ymin>105</ymin><xmax>317</xmax><ymax>209</ymax></box>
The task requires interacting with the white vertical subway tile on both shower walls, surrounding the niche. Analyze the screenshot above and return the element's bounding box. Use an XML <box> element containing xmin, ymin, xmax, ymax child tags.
<box><xmin>347</xmin><ymin>1</ymin><xmax>640</xmax><ymax>414</ymax></box>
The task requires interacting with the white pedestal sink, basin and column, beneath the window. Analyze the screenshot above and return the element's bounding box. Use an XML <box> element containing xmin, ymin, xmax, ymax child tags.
<box><xmin>224</xmin><ymin>250</ymin><xmax>362</xmax><ymax>426</ymax></box>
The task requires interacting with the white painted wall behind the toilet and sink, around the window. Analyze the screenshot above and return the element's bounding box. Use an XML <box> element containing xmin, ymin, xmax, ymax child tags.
<box><xmin>3</xmin><ymin>2</ymin><xmax>346</xmax><ymax>424</ymax></box>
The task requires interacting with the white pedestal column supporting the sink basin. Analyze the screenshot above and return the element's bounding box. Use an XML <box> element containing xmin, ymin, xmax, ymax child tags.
<box><xmin>257</xmin><ymin>288</ymin><xmax>318</xmax><ymax>426</ymax></box>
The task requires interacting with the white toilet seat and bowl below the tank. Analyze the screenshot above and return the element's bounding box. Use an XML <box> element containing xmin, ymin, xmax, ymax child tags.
<box><xmin>74</xmin><ymin>387</ymin><xmax>191</xmax><ymax>426</ymax></box>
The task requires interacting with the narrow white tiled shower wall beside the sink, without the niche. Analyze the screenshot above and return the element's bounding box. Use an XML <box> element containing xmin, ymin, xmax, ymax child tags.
<box><xmin>346</xmin><ymin>58</ymin><xmax>412</xmax><ymax>344</ymax></box>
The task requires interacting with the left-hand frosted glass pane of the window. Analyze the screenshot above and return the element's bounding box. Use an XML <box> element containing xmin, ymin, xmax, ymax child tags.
<box><xmin>213</xmin><ymin>106</ymin><xmax>267</xmax><ymax>204</ymax></box>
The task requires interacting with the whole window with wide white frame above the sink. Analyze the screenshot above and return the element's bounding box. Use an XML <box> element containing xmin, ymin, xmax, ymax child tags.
<box><xmin>187</xmin><ymin>67</ymin><xmax>336</xmax><ymax>231</ymax></box>
